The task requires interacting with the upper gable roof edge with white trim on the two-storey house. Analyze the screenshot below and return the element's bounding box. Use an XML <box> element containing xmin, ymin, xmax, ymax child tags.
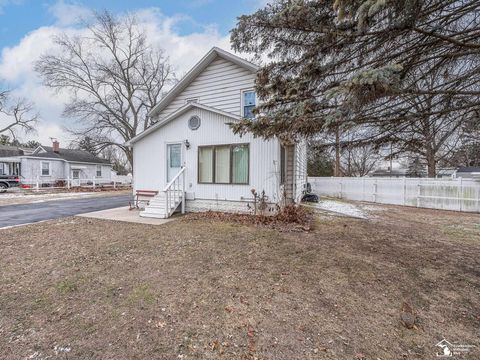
<box><xmin>148</xmin><ymin>47</ymin><xmax>259</xmax><ymax>116</ymax></box>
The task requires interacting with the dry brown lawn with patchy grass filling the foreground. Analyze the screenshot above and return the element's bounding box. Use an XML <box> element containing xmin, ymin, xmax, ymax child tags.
<box><xmin>0</xmin><ymin>207</ymin><xmax>480</xmax><ymax>360</ymax></box>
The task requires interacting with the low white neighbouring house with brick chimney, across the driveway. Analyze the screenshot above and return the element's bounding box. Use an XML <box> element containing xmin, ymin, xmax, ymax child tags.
<box><xmin>0</xmin><ymin>141</ymin><xmax>112</xmax><ymax>186</ymax></box>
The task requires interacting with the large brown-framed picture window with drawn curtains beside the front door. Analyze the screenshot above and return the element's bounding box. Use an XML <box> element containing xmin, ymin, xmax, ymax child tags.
<box><xmin>198</xmin><ymin>144</ymin><xmax>250</xmax><ymax>185</ymax></box>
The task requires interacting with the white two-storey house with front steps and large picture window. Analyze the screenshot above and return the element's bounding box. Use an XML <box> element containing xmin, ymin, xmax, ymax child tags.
<box><xmin>127</xmin><ymin>48</ymin><xmax>306</xmax><ymax>218</ymax></box>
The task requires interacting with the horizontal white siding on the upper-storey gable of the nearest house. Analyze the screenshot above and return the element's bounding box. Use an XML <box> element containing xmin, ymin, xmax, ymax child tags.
<box><xmin>158</xmin><ymin>58</ymin><xmax>255</xmax><ymax>118</ymax></box>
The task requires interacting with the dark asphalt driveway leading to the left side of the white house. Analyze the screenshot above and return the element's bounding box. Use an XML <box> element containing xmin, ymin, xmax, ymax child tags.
<box><xmin>0</xmin><ymin>195</ymin><xmax>131</xmax><ymax>228</ymax></box>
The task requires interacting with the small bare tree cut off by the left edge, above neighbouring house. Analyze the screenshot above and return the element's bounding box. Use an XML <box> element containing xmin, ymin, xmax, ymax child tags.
<box><xmin>0</xmin><ymin>91</ymin><xmax>38</xmax><ymax>139</ymax></box>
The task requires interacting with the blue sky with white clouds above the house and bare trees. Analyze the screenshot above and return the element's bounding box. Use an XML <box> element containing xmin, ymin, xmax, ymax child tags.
<box><xmin>0</xmin><ymin>0</ymin><xmax>267</xmax><ymax>144</ymax></box>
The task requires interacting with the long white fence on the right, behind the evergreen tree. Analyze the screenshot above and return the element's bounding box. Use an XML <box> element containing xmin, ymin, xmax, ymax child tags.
<box><xmin>308</xmin><ymin>177</ymin><xmax>480</xmax><ymax>212</ymax></box>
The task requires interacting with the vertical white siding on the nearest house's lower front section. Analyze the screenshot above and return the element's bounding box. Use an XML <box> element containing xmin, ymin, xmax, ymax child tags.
<box><xmin>133</xmin><ymin>107</ymin><xmax>280</xmax><ymax>202</ymax></box>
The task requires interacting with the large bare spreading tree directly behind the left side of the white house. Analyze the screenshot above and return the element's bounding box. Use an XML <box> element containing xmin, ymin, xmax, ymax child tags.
<box><xmin>35</xmin><ymin>12</ymin><xmax>174</xmax><ymax>165</ymax></box>
